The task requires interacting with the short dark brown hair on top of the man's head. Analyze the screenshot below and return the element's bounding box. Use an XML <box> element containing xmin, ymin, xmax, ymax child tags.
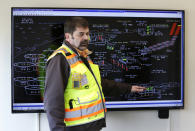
<box><xmin>64</xmin><ymin>16</ymin><xmax>88</xmax><ymax>34</ymax></box>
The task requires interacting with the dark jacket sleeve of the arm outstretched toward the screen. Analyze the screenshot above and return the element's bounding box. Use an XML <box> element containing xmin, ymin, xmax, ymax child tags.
<box><xmin>101</xmin><ymin>78</ymin><xmax>132</xmax><ymax>96</ymax></box>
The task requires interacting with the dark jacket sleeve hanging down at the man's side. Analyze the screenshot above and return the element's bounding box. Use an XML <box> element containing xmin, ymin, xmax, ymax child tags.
<box><xmin>44</xmin><ymin>54</ymin><xmax>70</xmax><ymax>131</ymax></box>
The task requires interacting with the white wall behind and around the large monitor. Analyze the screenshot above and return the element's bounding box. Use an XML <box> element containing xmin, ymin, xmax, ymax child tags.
<box><xmin>0</xmin><ymin>0</ymin><xmax>195</xmax><ymax>131</ymax></box>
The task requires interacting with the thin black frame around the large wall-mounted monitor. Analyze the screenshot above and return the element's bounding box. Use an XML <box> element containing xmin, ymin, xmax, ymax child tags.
<box><xmin>11</xmin><ymin>7</ymin><xmax>185</xmax><ymax>113</ymax></box>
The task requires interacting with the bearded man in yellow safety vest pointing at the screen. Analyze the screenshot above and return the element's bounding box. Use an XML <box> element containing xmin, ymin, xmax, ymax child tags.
<box><xmin>44</xmin><ymin>17</ymin><xmax>145</xmax><ymax>131</ymax></box>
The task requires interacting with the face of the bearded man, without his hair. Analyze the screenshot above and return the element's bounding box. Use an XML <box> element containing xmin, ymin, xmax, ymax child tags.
<box><xmin>65</xmin><ymin>27</ymin><xmax>89</xmax><ymax>51</ymax></box>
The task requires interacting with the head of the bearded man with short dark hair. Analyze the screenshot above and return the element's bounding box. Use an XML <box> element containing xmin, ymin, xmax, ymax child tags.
<box><xmin>64</xmin><ymin>17</ymin><xmax>89</xmax><ymax>50</ymax></box>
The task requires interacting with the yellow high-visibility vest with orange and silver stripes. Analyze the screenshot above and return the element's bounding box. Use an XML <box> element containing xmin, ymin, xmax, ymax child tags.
<box><xmin>48</xmin><ymin>44</ymin><xmax>106</xmax><ymax>126</ymax></box>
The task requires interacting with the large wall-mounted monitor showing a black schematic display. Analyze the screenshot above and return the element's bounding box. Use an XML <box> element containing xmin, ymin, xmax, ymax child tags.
<box><xmin>11</xmin><ymin>7</ymin><xmax>184</xmax><ymax>112</ymax></box>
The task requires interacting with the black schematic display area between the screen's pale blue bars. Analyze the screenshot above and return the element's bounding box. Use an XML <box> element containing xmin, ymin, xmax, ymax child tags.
<box><xmin>12</xmin><ymin>16</ymin><xmax>182</xmax><ymax>103</ymax></box>
